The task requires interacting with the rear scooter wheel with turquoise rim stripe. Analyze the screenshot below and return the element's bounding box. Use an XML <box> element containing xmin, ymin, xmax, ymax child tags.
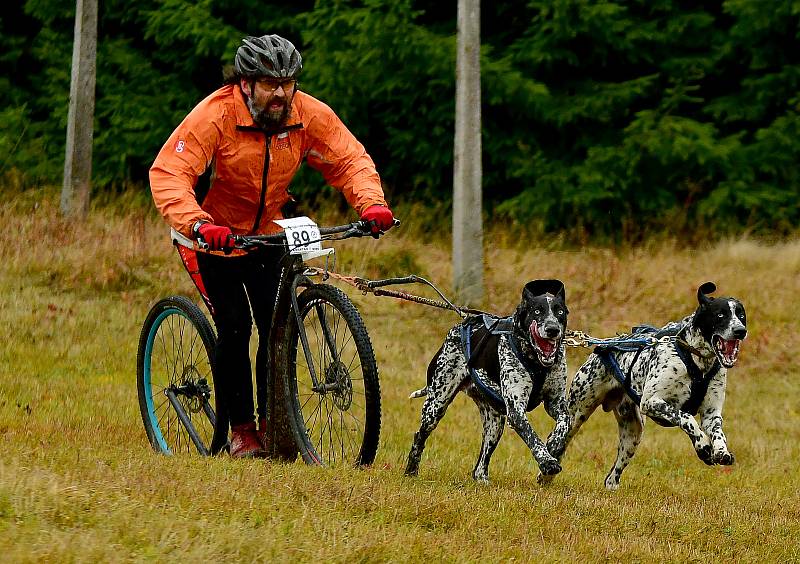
<box><xmin>136</xmin><ymin>296</ymin><xmax>228</xmax><ymax>455</ymax></box>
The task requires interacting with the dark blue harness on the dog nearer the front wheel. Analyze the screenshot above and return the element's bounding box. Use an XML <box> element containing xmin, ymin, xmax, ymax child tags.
<box><xmin>459</xmin><ymin>314</ymin><xmax>548</xmax><ymax>415</ymax></box>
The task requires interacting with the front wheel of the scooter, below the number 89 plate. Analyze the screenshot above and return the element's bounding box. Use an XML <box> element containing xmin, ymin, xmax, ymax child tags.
<box><xmin>282</xmin><ymin>284</ymin><xmax>381</xmax><ymax>466</ymax></box>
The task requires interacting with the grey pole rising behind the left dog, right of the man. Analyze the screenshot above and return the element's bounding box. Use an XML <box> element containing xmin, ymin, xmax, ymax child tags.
<box><xmin>453</xmin><ymin>0</ymin><xmax>483</xmax><ymax>304</ymax></box>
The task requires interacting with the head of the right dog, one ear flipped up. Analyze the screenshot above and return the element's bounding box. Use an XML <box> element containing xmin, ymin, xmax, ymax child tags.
<box><xmin>692</xmin><ymin>282</ymin><xmax>747</xmax><ymax>368</ymax></box>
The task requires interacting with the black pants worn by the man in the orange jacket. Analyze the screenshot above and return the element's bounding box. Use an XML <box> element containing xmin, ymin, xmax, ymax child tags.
<box><xmin>197</xmin><ymin>247</ymin><xmax>285</xmax><ymax>425</ymax></box>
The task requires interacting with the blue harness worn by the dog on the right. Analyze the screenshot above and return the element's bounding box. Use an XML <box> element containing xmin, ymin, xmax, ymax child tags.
<box><xmin>593</xmin><ymin>323</ymin><xmax>721</xmax><ymax>427</ymax></box>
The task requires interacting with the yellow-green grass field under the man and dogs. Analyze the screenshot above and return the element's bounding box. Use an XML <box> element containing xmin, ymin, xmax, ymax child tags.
<box><xmin>0</xmin><ymin>192</ymin><xmax>800</xmax><ymax>562</ymax></box>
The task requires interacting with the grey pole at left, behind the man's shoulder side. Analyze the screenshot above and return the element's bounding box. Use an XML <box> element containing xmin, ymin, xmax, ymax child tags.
<box><xmin>61</xmin><ymin>0</ymin><xmax>97</xmax><ymax>217</ymax></box>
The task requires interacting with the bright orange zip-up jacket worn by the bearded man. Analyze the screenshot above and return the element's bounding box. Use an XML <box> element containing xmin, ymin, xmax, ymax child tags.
<box><xmin>150</xmin><ymin>85</ymin><xmax>386</xmax><ymax>237</ymax></box>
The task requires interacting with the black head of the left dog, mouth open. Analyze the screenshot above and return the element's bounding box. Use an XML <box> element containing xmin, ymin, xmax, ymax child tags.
<box><xmin>514</xmin><ymin>280</ymin><xmax>569</xmax><ymax>367</ymax></box>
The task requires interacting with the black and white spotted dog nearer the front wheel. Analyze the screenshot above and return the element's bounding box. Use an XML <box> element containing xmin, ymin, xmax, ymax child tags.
<box><xmin>405</xmin><ymin>280</ymin><xmax>569</xmax><ymax>483</ymax></box>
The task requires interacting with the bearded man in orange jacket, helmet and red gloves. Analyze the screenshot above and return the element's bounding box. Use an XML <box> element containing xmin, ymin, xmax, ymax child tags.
<box><xmin>150</xmin><ymin>35</ymin><xmax>394</xmax><ymax>458</ymax></box>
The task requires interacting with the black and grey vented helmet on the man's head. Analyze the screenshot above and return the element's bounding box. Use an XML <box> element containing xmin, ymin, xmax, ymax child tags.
<box><xmin>234</xmin><ymin>35</ymin><xmax>303</xmax><ymax>78</ymax></box>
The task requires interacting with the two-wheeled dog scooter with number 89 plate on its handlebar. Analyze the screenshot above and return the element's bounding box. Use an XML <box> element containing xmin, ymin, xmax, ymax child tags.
<box><xmin>137</xmin><ymin>218</ymin><xmax>394</xmax><ymax>466</ymax></box>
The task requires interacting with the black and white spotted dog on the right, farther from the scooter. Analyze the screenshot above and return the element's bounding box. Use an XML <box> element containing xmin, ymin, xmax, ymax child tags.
<box><xmin>553</xmin><ymin>282</ymin><xmax>747</xmax><ymax>490</ymax></box>
